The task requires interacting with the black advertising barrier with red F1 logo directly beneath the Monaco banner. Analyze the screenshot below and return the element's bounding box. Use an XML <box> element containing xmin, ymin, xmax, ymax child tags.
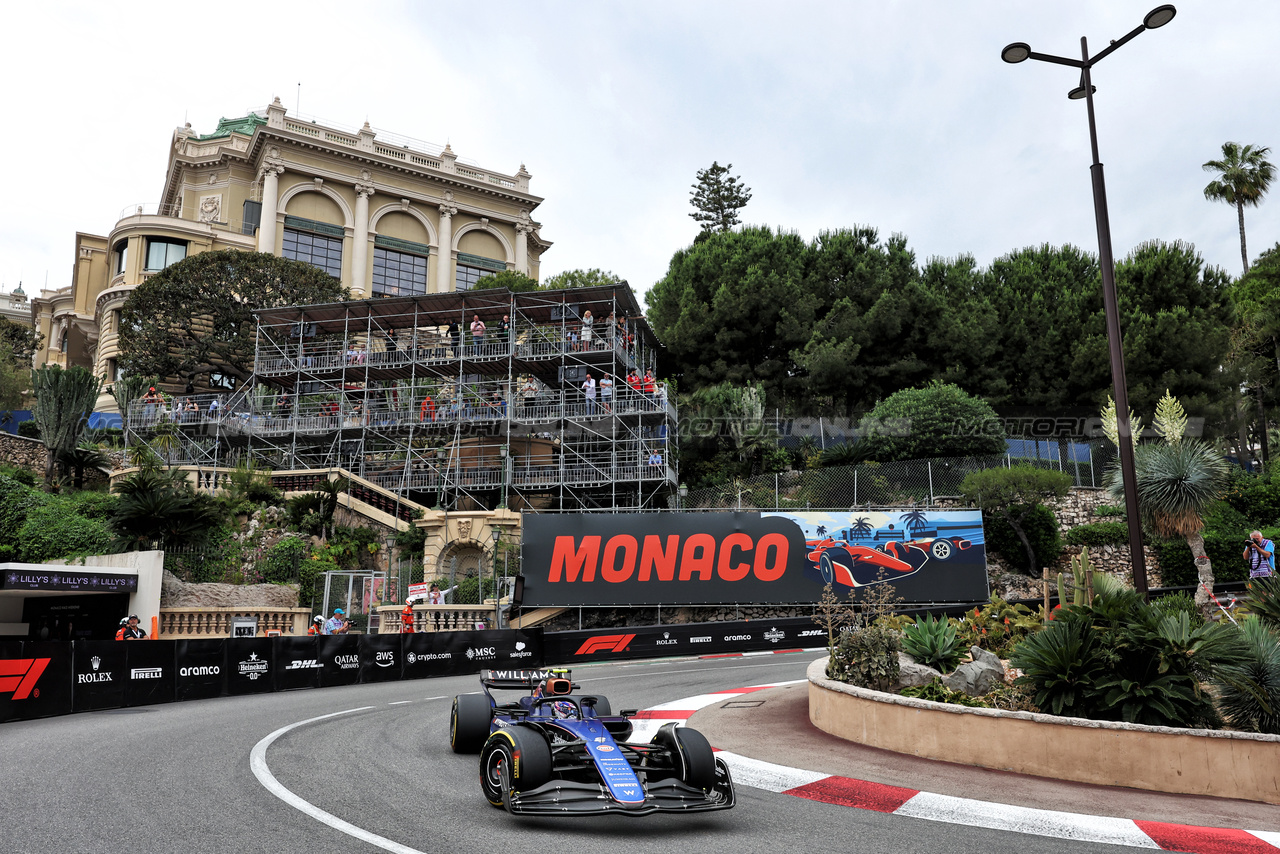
<box><xmin>543</xmin><ymin>617</ymin><xmax>827</xmax><ymax>666</ymax></box>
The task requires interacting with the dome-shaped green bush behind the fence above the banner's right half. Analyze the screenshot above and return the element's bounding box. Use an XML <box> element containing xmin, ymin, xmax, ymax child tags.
<box><xmin>859</xmin><ymin>382</ymin><xmax>1007</xmax><ymax>462</ymax></box>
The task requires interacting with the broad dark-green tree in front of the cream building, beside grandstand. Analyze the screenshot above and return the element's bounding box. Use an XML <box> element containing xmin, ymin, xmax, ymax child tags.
<box><xmin>120</xmin><ymin>250</ymin><xmax>351</xmax><ymax>380</ymax></box>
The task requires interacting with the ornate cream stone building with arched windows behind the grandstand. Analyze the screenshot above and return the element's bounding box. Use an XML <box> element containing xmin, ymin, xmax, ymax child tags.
<box><xmin>31</xmin><ymin>99</ymin><xmax>550</xmax><ymax>411</ymax></box>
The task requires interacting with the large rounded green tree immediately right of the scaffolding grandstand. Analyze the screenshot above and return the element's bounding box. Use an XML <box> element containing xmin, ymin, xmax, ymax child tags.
<box><xmin>645</xmin><ymin>227</ymin><xmax>817</xmax><ymax>396</ymax></box>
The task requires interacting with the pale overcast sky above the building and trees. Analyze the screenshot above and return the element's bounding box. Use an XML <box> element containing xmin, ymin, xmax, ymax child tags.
<box><xmin>0</xmin><ymin>0</ymin><xmax>1280</xmax><ymax>303</ymax></box>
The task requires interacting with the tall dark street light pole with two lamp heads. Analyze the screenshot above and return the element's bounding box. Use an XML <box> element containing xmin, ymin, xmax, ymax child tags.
<box><xmin>1000</xmin><ymin>4</ymin><xmax>1178</xmax><ymax>595</ymax></box>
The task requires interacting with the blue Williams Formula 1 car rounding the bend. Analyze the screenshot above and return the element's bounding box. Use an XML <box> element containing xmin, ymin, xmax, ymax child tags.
<box><xmin>449</xmin><ymin>670</ymin><xmax>735</xmax><ymax>816</ymax></box>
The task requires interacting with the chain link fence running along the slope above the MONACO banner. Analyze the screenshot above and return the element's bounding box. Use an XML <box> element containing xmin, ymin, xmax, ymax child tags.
<box><xmin>676</xmin><ymin>442</ymin><xmax>1116</xmax><ymax>510</ymax></box>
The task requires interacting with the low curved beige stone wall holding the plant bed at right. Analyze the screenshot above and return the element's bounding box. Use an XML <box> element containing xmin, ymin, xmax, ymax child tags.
<box><xmin>808</xmin><ymin>658</ymin><xmax>1280</xmax><ymax>804</ymax></box>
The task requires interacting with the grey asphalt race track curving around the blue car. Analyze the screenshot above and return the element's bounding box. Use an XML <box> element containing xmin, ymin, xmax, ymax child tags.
<box><xmin>0</xmin><ymin>653</ymin><xmax>1133</xmax><ymax>854</ymax></box>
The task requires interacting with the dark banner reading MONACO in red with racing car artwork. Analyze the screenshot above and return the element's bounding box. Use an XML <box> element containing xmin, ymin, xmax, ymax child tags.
<box><xmin>521</xmin><ymin>508</ymin><xmax>988</xmax><ymax>608</ymax></box>
